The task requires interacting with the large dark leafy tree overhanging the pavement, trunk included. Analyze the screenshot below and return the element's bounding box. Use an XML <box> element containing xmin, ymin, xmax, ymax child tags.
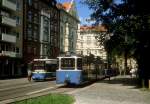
<box><xmin>83</xmin><ymin>0</ymin><xmax>150</xmax><ymax>87</ymax></box>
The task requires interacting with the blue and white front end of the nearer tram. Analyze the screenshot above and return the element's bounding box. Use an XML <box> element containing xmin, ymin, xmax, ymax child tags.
<box><xmin>56</xmin><ymin>56</ymin><xmax>83</xmax><ymax>85</ymax></box>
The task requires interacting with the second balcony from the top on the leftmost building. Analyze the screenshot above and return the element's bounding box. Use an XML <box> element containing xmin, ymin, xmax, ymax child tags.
<box><xmin>2</xmin><ymin>16</ymin><xmax>16</xmax><ymax>27</ymax></box>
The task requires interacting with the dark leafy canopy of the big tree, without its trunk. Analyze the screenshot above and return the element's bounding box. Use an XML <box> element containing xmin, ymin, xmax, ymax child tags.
<box><xmin>83</xmin><ymin>0</ymin><xmax>150</xmax><ymax>56</ymax></box>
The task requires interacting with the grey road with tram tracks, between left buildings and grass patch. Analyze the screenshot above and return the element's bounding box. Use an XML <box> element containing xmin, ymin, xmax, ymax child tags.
<box><xmin>0</xmin><ymin>78</ymin><xmax>78</xmax><ymax>104</ymax></box>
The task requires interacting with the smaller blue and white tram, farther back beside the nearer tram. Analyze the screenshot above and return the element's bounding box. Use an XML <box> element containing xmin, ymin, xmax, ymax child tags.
<box><xmin>32</xmin><ymin>59</ymin><xmax>57</xmax><ymax>80</ymax></box>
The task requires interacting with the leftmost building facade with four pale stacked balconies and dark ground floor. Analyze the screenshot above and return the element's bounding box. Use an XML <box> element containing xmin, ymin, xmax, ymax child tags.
<box><xmin>0</xmin><ymin>0</ymin><xmax>23</xmax><ymax>77</ymax></box>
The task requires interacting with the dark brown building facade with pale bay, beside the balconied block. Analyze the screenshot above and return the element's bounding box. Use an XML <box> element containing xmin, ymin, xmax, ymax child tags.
<box><xmin>23</xmin><ymin>0</ymin><xmax>59</xmax><ymax>64</ymax></box>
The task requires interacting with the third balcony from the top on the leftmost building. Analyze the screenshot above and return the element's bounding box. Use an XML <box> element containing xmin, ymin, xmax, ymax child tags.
<box><xmin>1</xmin><ymin>33</ymin><xmax>16</xmax><ymax>43</ymax></box>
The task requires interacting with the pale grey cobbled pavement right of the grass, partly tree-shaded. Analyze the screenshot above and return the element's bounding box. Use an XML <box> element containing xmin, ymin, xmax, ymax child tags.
<box><xmin>72</xmin><ymin>76</ymin><xmax>150</xmax><ymax>104</ymax></box>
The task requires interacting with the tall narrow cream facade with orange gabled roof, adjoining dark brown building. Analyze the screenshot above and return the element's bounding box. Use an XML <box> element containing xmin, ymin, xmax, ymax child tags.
<box><xmin>58</xmin><ymin>0</ymin><xmax>79</xmax><ymax>53</ymax></box>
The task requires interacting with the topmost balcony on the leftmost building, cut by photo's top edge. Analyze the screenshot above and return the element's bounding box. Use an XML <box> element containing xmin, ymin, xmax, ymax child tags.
<box><xmin>2</xmin><ymin>0</ymin><xmax>17</xmax><ymax>11</ymax></box>
